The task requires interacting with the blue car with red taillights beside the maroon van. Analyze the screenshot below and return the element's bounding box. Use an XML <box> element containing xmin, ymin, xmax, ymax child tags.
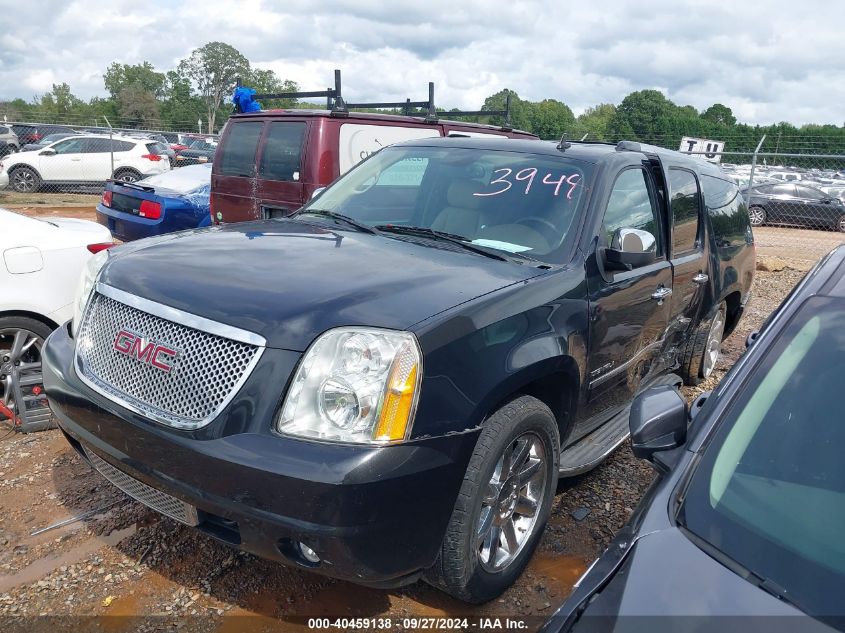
<box><xmin>97</xmin><ymin>165</ymin><xmax>211</xmax><ymax>242</ymax></box>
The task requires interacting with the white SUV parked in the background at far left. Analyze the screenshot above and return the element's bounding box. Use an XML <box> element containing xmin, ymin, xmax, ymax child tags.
<box><xmin>0</xmin><ymin>135</ymin><xmax>170</xmax><ymax>193</ymax></box>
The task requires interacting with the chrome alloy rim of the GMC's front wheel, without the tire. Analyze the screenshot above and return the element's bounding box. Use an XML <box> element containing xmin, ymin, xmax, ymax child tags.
<box><xmin>476</xmin><ymin>432</ymin><xmax>548</xmax><ymax>572</ymax></box>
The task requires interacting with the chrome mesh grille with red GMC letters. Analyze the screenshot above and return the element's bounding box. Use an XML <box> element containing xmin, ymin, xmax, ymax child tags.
<box><xmin>76</xmin><ymin>284</ymin><xmax>263</xmax><ymax>429</ymax></box>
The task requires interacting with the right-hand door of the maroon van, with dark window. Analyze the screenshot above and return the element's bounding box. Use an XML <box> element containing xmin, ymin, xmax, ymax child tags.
<box><xmin>255</xmin><ymin>119</ymin><xmax>320</xmax><ymax>218</ymax></box>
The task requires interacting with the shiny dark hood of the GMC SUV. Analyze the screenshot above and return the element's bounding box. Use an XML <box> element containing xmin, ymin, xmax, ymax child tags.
<box><xmin>100</xmin><ymin>220</ymin><xmax>545</xmax><ymax>351</ymax></box>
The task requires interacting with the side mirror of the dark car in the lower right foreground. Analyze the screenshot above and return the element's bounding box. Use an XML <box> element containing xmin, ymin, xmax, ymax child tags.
<box><xmin>628</xmin><ymin>385</ymin><xmax>689</xmax><ymax>459</ymax></box>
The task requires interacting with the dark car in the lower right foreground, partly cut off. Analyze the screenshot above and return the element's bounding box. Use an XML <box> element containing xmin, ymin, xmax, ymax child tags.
<box><xmin>544</xmin><ymin>246</ymin><xmax>845</xmax><ymax>633</ymax></box>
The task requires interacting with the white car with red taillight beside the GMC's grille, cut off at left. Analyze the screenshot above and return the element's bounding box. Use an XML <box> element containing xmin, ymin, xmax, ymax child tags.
<box><xmin>0</xmin><ymin>209</ymin><xmax>113</xmax><ymax>431</ymax></box>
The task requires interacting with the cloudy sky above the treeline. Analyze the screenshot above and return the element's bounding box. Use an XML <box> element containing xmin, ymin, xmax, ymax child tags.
<box><xmin>0</xmin><ymin>0</ymin><xmax>845</xmax><ymax>125</ymax></box>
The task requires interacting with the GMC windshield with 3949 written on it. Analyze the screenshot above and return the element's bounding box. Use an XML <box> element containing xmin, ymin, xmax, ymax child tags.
<box><xmin>302</xmin><ymin>146</ymin><xmax>592</xmax><ymax>262</ymax></box>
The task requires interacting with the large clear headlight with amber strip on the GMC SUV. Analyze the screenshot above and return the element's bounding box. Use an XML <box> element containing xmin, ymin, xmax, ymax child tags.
<box><xmin>276</xmin><ymin>328</ymin><xmax>422</xmax><ymax>444</ymax></box>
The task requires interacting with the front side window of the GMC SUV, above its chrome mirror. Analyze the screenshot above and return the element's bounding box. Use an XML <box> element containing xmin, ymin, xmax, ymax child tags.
<box><xmin>602</xmin><ymin>169</ymin><xmax>663</xmax><ymax>254</ymax></box>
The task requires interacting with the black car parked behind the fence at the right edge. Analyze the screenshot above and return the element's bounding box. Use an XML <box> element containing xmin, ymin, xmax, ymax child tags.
<box><xmin>748</xmin><ymin>182</ymin><xmax>845</xmax><ymax>232</ymax></box>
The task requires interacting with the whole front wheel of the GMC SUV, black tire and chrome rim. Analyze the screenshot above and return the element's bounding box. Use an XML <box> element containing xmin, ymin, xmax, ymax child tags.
<box><xmin>425</xmin><ymin>396</ymin><xmax>560</xmax><ymax>604</ymax></box>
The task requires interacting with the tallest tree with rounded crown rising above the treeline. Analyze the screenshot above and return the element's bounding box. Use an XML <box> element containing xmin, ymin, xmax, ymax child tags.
<box><xmin>178</xmin><ymin>42</ymin><xmax>250</xmax><ymax>131</ymax></box>
